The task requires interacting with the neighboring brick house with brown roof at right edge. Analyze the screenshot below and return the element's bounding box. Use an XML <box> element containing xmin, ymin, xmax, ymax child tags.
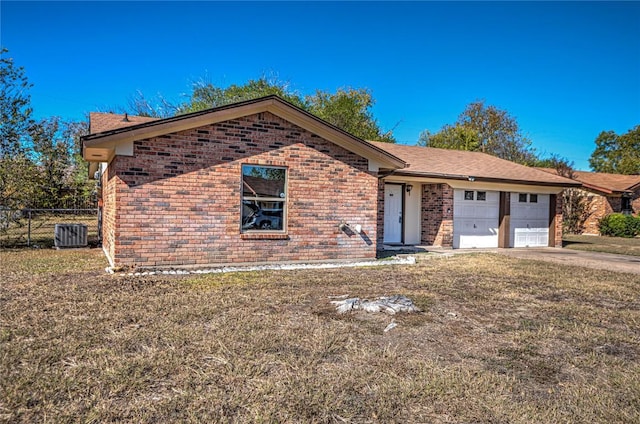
<box><xmin>541</xmin><ymin>168</ymin><xmax>640</xmax><ymax>235</ymax></box>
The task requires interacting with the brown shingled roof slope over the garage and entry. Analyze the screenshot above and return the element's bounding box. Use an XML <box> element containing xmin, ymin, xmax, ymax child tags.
<box><xmin>371</xmin><ymin>142</ymin><xmax>580</xmax><ymax>187</ymax></box>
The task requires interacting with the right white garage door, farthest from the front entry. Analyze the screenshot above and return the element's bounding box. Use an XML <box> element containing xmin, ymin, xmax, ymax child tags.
<box><xmin>510</xmin><ymin>193</ymin><xmax>549</xmax><ymax>247</ymax></box>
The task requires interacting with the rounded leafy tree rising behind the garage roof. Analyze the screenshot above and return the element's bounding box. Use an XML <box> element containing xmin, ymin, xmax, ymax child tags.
<box><xmin>418</xmin><ymin>100</ymin><xmax>536</xmax><ymax>165</ymax></box>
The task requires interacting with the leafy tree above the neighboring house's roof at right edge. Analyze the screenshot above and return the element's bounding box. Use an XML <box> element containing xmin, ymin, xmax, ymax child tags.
<box><xmin>589</xmin><ymin>125</ymin><xmax>640</xmax><ymax>175</ymax></box>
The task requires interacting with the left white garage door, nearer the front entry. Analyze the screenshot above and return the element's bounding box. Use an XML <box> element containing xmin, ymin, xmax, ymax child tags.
<box><xmin>453</xmin><ymin>189</ymin><xmax>500</xmax><ymax>249</ymax></box>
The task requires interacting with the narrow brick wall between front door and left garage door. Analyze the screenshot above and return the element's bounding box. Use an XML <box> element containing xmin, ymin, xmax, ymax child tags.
<box><xmin>422</xmin><ymin>184</ymin><xmax>453</xmax><ymax>247</ymax></box>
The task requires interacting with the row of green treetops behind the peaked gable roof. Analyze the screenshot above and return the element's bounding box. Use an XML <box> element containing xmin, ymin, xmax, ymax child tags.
<box><xmin>128</xmin><ymin>76</ymin><xmax>395</xmax><ymax>142</ymax></box>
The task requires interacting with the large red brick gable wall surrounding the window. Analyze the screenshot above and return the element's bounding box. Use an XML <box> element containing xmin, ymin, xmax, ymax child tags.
<box><xmin>105</xmin><ymin>113</ymin><xmax>378</xmax><ymax>267</ymax></box>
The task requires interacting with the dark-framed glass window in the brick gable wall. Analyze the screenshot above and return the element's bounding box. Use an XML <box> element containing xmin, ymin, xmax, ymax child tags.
<box><xmin>242</xmin><ymin>165</ymin><xmax>286</xmax><ymax>231</ymax></box>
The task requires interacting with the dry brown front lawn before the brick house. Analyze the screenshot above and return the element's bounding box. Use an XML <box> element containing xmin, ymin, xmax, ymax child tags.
<box><xmin>0</xmin><ymin>251</ymin><xmax>640</xmax><ymax>423</ymax></box>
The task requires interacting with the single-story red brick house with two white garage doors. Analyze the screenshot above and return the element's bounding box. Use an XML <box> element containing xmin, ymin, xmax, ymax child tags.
<box><xmin>83</xmin><ymin>96</ymin><xmax>579</xmax><ymax>267</ymax></box>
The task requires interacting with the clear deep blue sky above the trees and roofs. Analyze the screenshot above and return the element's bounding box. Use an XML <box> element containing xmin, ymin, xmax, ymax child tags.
<box><xmin>0</xmin><ymin>1</ymin><xmax>640</xmax><ymax>170</ymax></box>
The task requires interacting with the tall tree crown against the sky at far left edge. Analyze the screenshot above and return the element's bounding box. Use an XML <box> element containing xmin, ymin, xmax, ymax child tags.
<box><xmin>0</xmin><ymin>48</ymin><xmax>34</xmax><ymax>159</ymax></box>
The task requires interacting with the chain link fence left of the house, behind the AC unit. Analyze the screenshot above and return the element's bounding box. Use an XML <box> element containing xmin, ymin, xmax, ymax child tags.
<box><xmin>0</xmin><ymin>208</ymin><xmax>100</xmax><ymax>248</ymax></box>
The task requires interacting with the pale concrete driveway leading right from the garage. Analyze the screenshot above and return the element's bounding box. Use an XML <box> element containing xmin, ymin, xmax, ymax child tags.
<box><xmin>495</xmin><ymin>247</ymin><xmax>640</xmax><ymax>274</ymax></box>
